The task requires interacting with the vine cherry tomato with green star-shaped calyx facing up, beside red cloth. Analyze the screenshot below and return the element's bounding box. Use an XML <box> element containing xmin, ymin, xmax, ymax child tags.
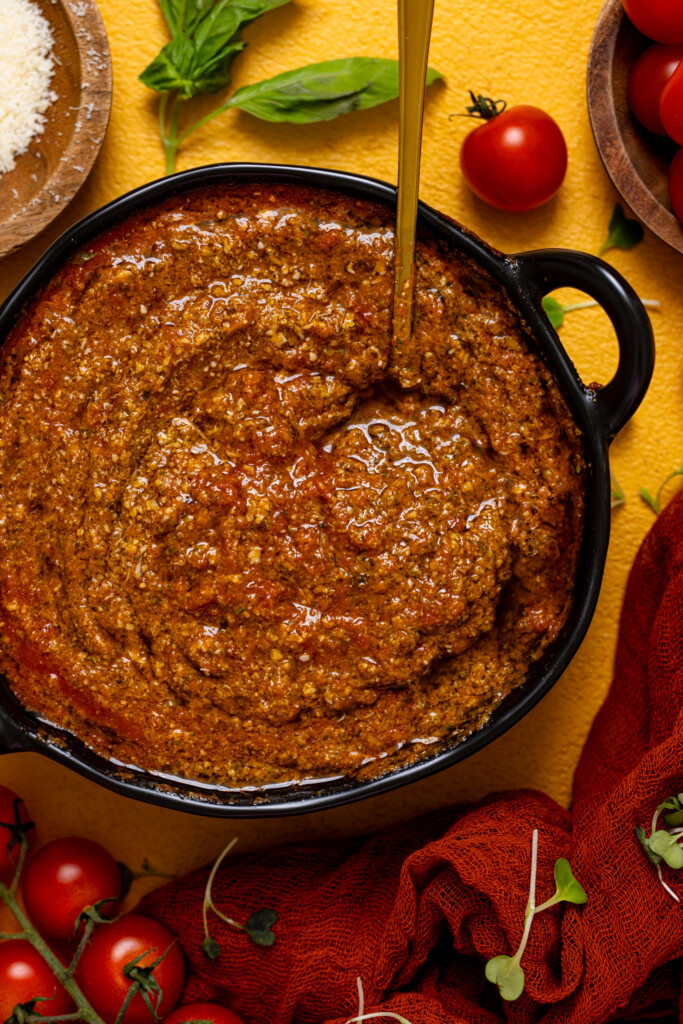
<box><xmin>76</xmin><ymin>913</ymin><xmax>185</xmax><ymax>1024</ymax></box>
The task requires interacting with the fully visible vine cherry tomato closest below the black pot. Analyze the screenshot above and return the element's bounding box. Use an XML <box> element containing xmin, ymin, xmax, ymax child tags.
<box><xmin>22</xmin><ymin>836</ymin><xmax>121</xmax><ymax>939</ymax></box>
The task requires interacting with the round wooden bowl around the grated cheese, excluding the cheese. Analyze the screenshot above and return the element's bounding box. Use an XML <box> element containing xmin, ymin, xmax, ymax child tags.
<box><xmin>0</xmin><ymin>0</ymin><xmax>112</xmax><ymax>256</ymax></box>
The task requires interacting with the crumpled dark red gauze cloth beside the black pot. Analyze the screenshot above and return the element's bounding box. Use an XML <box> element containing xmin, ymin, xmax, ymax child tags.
<box><xmin>141</xmin><ymin>495</ymin><xmax>683</xmax><ymax>1024</ymax></box>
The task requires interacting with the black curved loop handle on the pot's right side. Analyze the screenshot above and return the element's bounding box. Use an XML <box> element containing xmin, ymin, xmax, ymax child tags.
<box><xmin>512</xmin><ymin>249</ymin><xmax>654</xmax><ymax>441</ymax></box>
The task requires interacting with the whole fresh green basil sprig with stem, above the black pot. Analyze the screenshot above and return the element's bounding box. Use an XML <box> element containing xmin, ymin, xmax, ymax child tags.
<box><xmin>139</xmin><ymin>0</ymin><xmax>441</xmax><ymax>173</ymax></box>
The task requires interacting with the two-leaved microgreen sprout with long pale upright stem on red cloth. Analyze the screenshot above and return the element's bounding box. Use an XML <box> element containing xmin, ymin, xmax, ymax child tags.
<box><xmin>485</xmin><ymin>828</ymin><xmax>588</xmax><ymax>1002</ymax></box>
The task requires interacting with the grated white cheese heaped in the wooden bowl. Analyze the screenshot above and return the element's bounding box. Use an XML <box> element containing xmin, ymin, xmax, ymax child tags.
<box><xmin>0</xmin><ymin>0</ymin><xmax>57</xmax><ymax>174</ymax></box>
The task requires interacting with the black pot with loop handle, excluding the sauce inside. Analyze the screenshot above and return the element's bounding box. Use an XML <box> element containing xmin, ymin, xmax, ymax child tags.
<box><xmin>0</xmin><ymin>164</ymin><xmax>654</xmax><ymax>817</ymax></box>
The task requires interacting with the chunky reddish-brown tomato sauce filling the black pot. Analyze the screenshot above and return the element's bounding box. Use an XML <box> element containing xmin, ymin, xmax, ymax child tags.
<box><xmin>0</xmin><ymin>185</ymin><xmax>585</xmax><ymax>786</ymax></box>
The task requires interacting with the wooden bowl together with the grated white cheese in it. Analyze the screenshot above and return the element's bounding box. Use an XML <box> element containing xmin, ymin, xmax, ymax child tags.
<box><xmin>0</xmin><ymin>0</ymin><xmax>112</xmax><ymax>257</ymax></box>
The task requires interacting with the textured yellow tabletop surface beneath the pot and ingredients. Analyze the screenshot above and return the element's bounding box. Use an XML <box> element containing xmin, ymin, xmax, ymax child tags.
<box><xmin>0</xmin><ymin>0</ymin><xmax>683</xmax><ymax>894</ymax></box>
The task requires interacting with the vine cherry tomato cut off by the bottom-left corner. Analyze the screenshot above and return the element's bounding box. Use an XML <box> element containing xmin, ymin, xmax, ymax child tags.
<box><xmin>0</xmin><ymin>939</ymin><xmax>74</xmax><ymax>1021</ymax></box>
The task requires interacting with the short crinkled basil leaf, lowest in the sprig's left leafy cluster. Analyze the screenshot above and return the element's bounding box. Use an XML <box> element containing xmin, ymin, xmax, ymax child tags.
<box><xmin>140</xmin><ymin>33</ymin><xmax>246</xmax><ymax>99</ymax></box>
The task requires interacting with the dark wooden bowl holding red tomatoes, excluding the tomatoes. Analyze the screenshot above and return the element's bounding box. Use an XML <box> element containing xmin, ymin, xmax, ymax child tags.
<box><xmin>588</xmin><ymin>0</ymin><xmax>683</xmax><ymax>252</ymax></box>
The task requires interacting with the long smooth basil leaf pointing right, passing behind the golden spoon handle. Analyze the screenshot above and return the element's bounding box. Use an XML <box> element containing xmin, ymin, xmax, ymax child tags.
<box><xmin>225</xmin><ymin>57</ymin><xmax>442</xmax><ymax>124</ymax></box>
